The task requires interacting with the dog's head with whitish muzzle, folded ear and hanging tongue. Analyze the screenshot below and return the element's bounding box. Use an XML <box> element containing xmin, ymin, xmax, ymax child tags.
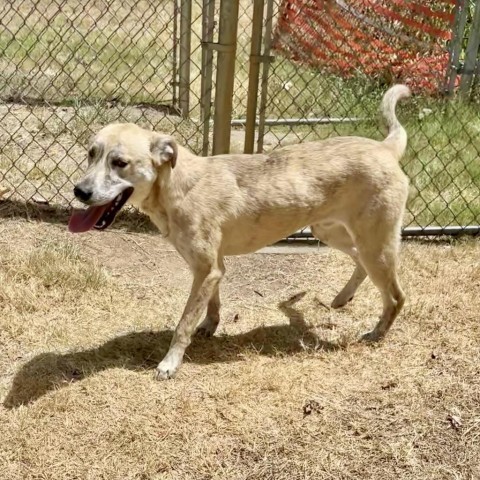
<box><xmin>69</xmin><ymin>124</ymin><xmax>177</xmax><ymax>232</ymax></box>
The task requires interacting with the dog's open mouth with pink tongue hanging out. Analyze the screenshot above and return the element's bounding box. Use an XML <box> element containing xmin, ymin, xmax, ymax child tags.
<box><xmin>68</xmin><ymin>187</ymin><xmax>133</xmax><ymax>233</ymax></box>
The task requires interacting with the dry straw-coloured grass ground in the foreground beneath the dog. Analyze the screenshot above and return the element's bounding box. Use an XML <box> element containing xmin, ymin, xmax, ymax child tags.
<box><xmin>0</xmin><ymin>219</ymin><xmax>480</xmax><ymax>480</ymax></box>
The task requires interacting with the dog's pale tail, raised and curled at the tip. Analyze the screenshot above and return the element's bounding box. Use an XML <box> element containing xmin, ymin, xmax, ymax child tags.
<box><xmin>381</xmin><ymin>85</ymin><xmax>411</xmax><ymax>160</ymax></box>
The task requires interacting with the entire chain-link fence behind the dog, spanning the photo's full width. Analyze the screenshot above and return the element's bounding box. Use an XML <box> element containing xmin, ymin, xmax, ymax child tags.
<box><xmin>0</xmin><ymin>0</ymin><xmax>480</xmax><ymax>236</ymax></box>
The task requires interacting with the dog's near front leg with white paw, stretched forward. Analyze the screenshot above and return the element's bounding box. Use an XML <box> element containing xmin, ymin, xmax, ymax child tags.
<box><xmin>155</xmin><ymin>266</ymin><xmax>223</xmax><ymax>380</ymax></box>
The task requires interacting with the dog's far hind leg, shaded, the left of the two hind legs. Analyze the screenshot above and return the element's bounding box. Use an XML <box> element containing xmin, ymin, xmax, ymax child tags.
<box><xmin>311</xmin><ymin>224</ymin><xmax>367</xmax><ymax>308</ymax></box>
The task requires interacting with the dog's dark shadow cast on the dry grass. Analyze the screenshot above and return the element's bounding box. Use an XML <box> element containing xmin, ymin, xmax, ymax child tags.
<box><xmin>4</xmin><ymin>292</ymin><xmax>342</xmax><ymax>408</ymax></box>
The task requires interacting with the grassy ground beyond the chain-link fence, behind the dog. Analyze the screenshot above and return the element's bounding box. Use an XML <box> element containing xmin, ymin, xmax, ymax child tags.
<box><xmin>0</xmin><ymin>0</ymin><xmax>480</xmax><ymax>226</ymax></box>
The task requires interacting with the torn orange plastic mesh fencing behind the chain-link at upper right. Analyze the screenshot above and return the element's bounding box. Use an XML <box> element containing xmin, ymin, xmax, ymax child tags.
<box><xmin>274</xmin><ymin>0</ymin><xmax>455</xmax><ymax>93</ymax></box>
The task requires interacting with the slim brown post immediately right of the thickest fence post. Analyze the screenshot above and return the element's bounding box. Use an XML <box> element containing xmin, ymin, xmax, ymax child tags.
<box><xmin>243</xmin><ymin>0</ymin><xmax>264</xmax><ymax>153</ymax></box>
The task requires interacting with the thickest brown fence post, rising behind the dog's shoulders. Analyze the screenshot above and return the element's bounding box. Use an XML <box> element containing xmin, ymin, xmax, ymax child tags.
<box><xmin>213</xmin><ymin>0</ymin><xmax>239</xmax><ymax>155</ymax></box>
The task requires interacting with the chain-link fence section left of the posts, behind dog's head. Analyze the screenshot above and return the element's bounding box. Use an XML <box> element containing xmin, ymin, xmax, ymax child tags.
<box><xmin>0</xmin><ymin>0</ymin><xmax>201</xmax><ymax>205</ymax></box>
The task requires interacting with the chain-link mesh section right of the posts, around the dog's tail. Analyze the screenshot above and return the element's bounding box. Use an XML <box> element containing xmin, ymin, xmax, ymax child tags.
<box><xmin>233</xmin><ymin>0</ymin><xmax>480</xmax><ymax>232</ymax></box>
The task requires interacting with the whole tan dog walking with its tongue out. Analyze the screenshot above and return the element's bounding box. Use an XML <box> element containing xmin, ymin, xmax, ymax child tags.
<box><xmin>69</xmin><ymin>85</ymin><xmax>410</xmax><ymax>379</ymax></box>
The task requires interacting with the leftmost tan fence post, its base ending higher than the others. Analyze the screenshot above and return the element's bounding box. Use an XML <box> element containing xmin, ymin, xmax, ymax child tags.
<box><xmin>178</xmin><ymin>0</ymin><xmax>192</xmax><ymax>118</ymax></box>
